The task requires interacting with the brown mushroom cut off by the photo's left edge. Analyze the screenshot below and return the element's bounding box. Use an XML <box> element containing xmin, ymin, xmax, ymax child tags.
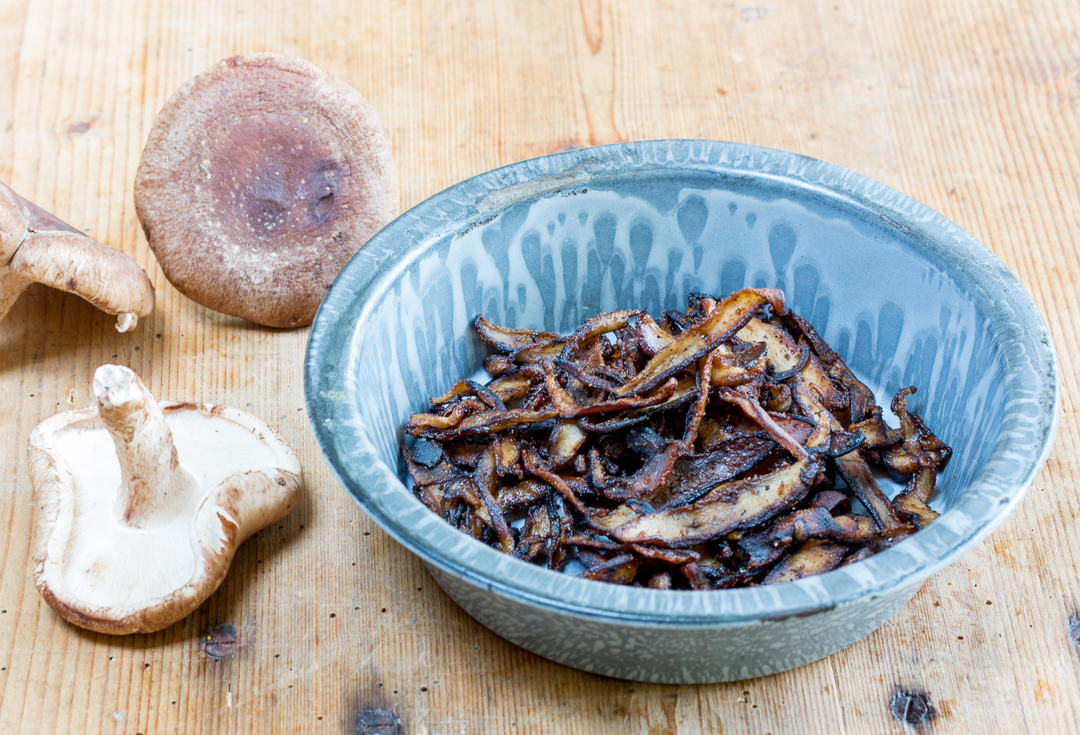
<box><xmin>0</xmin><ymin>183</ymin><xmax>153</xmax><ymax>331</ymax></box>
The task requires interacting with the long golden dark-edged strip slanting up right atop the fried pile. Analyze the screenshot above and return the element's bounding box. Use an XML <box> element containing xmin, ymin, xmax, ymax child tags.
<box><xmin>615</xmin><ymin>288</ymin><xmax>784</xmax><ymax>396</ymax></box>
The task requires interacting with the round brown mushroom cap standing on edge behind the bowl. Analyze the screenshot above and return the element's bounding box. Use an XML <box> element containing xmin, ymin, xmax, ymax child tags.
<box><xmin>135</xmin><ymin>54</ymin><xmax>397</xmax><ymax>327</ymax></box>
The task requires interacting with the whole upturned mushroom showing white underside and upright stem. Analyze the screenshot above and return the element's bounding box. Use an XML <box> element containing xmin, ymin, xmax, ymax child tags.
<box><xmin>28</xmin><ymin>365</ymin><xmax>301</xmax><ymax>635</ymax></box>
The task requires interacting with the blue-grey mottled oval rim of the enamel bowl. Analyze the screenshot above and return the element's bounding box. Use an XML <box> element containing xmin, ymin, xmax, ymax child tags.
<box><xmin>305</xmin><ymin>139</ymin><xmax>1061</xmax><ymax>627</ymax></box>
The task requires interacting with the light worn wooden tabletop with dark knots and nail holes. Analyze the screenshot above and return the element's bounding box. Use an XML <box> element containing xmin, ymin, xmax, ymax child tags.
<box><xmin>0</xmin><ymin>0</ymin><xmax>1080</xmax><ymax>735</ymax></box>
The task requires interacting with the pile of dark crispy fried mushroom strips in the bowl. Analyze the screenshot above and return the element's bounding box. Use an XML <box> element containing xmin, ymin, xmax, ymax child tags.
<box><xmin>402</xmin><ymin>288</ymin><xmax>950</xmax><ymax>589</ymax></box>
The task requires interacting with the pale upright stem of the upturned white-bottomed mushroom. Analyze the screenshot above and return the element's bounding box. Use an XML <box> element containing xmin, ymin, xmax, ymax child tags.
<box><xmin>94</xmin><ymin>365</ymin><xmax>197</xmax><ymax>529</ymax></box>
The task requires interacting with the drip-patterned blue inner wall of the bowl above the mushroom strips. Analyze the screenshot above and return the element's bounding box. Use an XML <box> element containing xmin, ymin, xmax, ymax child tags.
<box><xmin>358</xmin><ymin>171</ymin><xmax>1005</xmax><ymax>512</ymax></box>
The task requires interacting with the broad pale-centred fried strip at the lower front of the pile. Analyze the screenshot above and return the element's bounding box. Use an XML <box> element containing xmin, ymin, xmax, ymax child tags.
<box><xmin>610</xmin><ymin>455</ymin><xmax>824</xmax><ymax>548</ymax></box>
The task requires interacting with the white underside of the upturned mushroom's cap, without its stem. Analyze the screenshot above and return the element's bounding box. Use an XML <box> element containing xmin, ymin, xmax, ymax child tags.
<box><xmin>38</xmin><ymin>403</ymin><xmax>299</xmax><ymax>627</ymax></box>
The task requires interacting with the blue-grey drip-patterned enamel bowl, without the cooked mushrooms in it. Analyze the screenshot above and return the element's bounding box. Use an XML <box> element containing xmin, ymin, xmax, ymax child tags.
<box><xmin>305</xmin><ymin>140</ymin><xmax>1059</xmax><ymax>683</ymax></box>
